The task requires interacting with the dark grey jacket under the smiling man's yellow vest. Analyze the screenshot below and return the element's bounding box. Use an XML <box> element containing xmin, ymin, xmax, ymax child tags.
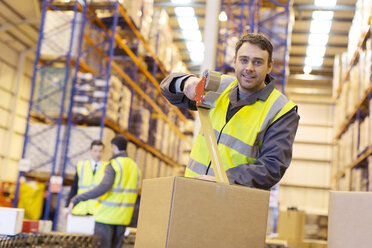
<box><xmin>160</xmin><ymin>73</ymin><xmax>300</xmax><ymax>190</ymax></box>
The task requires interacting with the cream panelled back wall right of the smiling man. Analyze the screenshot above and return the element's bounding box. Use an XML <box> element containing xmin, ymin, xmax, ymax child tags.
<box><xmin>279</xmin><ymin>101</ymin><xmax>333</xmax><ymax>214</ymax></box>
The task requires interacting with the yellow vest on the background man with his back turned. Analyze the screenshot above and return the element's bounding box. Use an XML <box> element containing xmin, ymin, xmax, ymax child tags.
<box><xmin>94</xmin><ymin>157</ymin><xmax>140</xmax><ymax>225</ymax></box>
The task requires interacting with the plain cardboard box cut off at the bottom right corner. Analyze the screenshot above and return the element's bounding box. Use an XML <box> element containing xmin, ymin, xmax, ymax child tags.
<box><xmin>328</xmin><ymin>191</ymin><xmax>372</xmax><ymax>248</ymax></box>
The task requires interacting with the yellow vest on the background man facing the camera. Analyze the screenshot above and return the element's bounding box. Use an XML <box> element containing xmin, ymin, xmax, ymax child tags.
<box><xmin>72</xmin><ymin>160</ymin><xmax>107</xmax><ymax>215</ymax></box>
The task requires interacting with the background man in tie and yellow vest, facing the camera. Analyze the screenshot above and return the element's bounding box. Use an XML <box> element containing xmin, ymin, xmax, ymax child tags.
<box><xmin>64</xmin><ymin>140</ymin><xmax>107</xmax><ymax>215</ymax></box>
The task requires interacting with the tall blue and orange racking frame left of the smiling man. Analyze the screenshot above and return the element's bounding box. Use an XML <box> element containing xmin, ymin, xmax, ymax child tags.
<box><xmin>13</xmin><ymin>0</ymin><xmax>193</xmax><ymax>230</ymax></box>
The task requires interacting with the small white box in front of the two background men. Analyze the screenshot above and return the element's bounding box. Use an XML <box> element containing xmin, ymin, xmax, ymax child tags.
<box><xmin>66</xmin><ymin>214</ymin><xmax>95</xmax><ymax>234</ymax></box>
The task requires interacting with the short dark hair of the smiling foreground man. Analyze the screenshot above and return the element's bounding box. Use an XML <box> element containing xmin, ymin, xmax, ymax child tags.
<box><xmin>235</xmin><ymin>33</ymin><xmax>273</xmax><ymax>63</ymax></box>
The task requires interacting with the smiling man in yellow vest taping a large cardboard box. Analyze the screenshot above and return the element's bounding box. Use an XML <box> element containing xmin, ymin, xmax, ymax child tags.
<box><xmin>161</xmin><ymin>34</ymin><xmax>299</xmax><ymax>190</ymax></box>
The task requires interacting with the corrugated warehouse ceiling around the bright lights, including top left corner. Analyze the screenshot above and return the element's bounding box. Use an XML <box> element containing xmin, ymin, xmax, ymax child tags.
<box><xmin>0</xmin><ymin>0</ymin><xmax>356</xmax><ymax>101</ymax></box>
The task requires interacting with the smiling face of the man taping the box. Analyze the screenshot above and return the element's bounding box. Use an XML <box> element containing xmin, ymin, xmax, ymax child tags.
<box><xmin>234</xmin><ymin>42</ymin><xmax>273</xmax><ymax>94</ymax></box>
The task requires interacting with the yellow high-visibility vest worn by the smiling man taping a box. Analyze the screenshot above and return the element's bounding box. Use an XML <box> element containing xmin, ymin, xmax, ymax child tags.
<box><xmin>185</xmin><ymin>80</ymin><xmax>296</xmax><ymax>177</ymax></box>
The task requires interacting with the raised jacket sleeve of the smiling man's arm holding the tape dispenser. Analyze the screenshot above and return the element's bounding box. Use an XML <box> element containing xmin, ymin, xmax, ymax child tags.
<box><xmin>160</xmin><ymin>72</ymin><xmax>196</xmax><ymax>110</ymax></box>
